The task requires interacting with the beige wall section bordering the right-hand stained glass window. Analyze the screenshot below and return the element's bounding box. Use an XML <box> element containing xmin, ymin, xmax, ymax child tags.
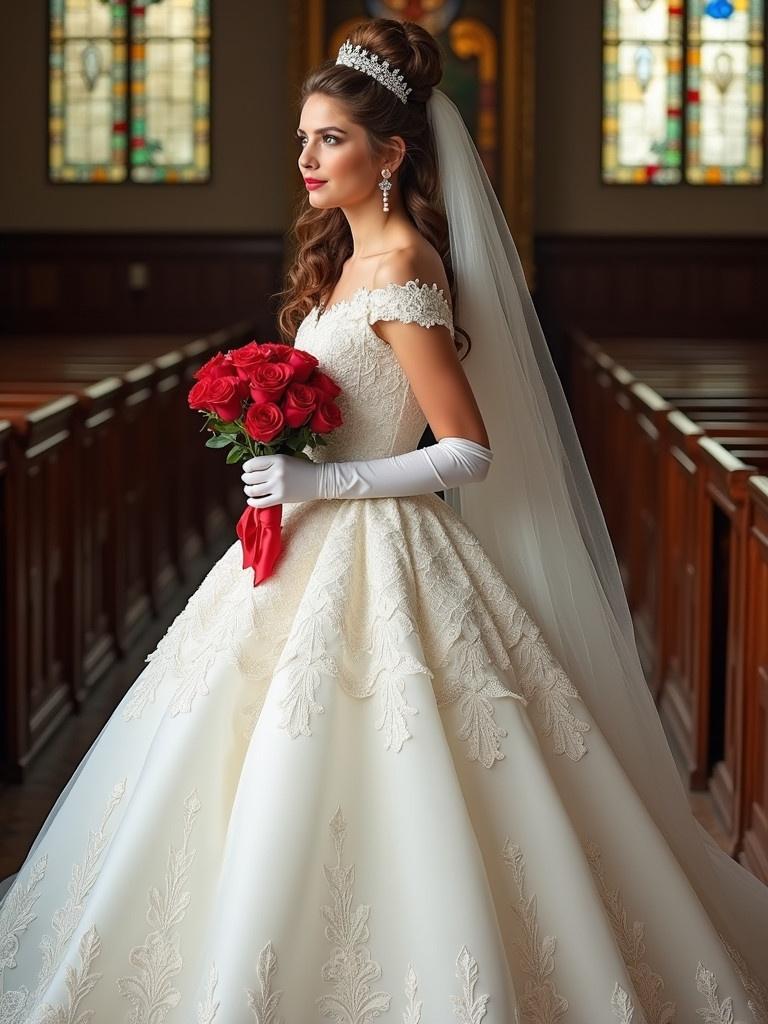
<box><xmin>535</xmin><ymin>0</ymin><xmax>768</xmax><ymax>236</ymax></box>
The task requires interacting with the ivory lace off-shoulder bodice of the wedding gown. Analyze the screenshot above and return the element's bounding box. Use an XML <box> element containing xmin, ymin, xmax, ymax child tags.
<box><xmin>296</xmin><ymin>278</ymin><xmax>454</xmax><ymax>462</ymax></box>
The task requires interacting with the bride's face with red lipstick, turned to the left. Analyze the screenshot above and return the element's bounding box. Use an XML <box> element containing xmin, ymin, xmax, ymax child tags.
<box><xmin>296</xmin><ymin>92</ymin><xmax>391</xmax><ymax>210</ymax></box>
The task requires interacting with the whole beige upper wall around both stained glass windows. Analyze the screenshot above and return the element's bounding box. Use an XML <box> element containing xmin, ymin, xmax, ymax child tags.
<box><xmin>0</xmin><ymin>0</ymin><xmax>768</xmax><ymax>236</ymax></box>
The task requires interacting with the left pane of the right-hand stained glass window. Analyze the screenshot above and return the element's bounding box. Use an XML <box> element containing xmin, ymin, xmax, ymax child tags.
<box><xmin>602</xmin><ymin>0</ymin><xmax>682</xmax><ymax>184</ymax></box>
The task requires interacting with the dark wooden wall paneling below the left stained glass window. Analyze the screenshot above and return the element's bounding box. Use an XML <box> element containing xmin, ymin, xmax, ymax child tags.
<box><xmin>0</xmin><ymin>233</ymin><xmax>284</xmax><ymax>339</ymax></box>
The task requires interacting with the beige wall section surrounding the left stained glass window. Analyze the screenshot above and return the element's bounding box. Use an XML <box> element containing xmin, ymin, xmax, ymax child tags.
<box><xmin>0</xmin><ymin>0</ymin><xmax>295</xmax><ymax>231</ymax></box>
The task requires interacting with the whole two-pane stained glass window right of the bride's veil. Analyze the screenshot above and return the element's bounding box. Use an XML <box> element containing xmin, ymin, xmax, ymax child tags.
<box><xmin>602</xmin><ymin>0</ymin><xmax>765</xmax><ymax>184</ymax></box>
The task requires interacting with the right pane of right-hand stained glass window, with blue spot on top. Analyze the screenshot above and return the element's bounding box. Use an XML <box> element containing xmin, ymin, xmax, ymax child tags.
<box><xmin>686</xmin><ymin>0</ymin><xmax>765</xmax><ymax>184</ymax></box>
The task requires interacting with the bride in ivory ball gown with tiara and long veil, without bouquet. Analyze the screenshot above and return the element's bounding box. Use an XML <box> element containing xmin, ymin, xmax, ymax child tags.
<box><xmin>0</xmin><ymin>18</ymin><xmax>768</xmax><ymax>1024</ymax></box>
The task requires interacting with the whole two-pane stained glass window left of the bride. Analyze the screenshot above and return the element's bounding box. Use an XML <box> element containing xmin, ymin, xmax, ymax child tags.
<box><xmin>48</xmin><ymin>0</ymin><xmax>210</xmax><ymax>183</ymax></box>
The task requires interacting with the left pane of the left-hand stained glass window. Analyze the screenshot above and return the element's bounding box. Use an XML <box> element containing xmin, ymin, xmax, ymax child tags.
<box><xmin>48</xmin><ymin>0</ymin><xmax>127</xmax><ymax>182</ymax></box>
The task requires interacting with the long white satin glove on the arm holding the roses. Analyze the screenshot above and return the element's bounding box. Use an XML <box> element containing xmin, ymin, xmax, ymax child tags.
<box><xmin>242</xmin><ymin>437</ymin><xmax>494</xmax><ymax>508</ymax></box>
